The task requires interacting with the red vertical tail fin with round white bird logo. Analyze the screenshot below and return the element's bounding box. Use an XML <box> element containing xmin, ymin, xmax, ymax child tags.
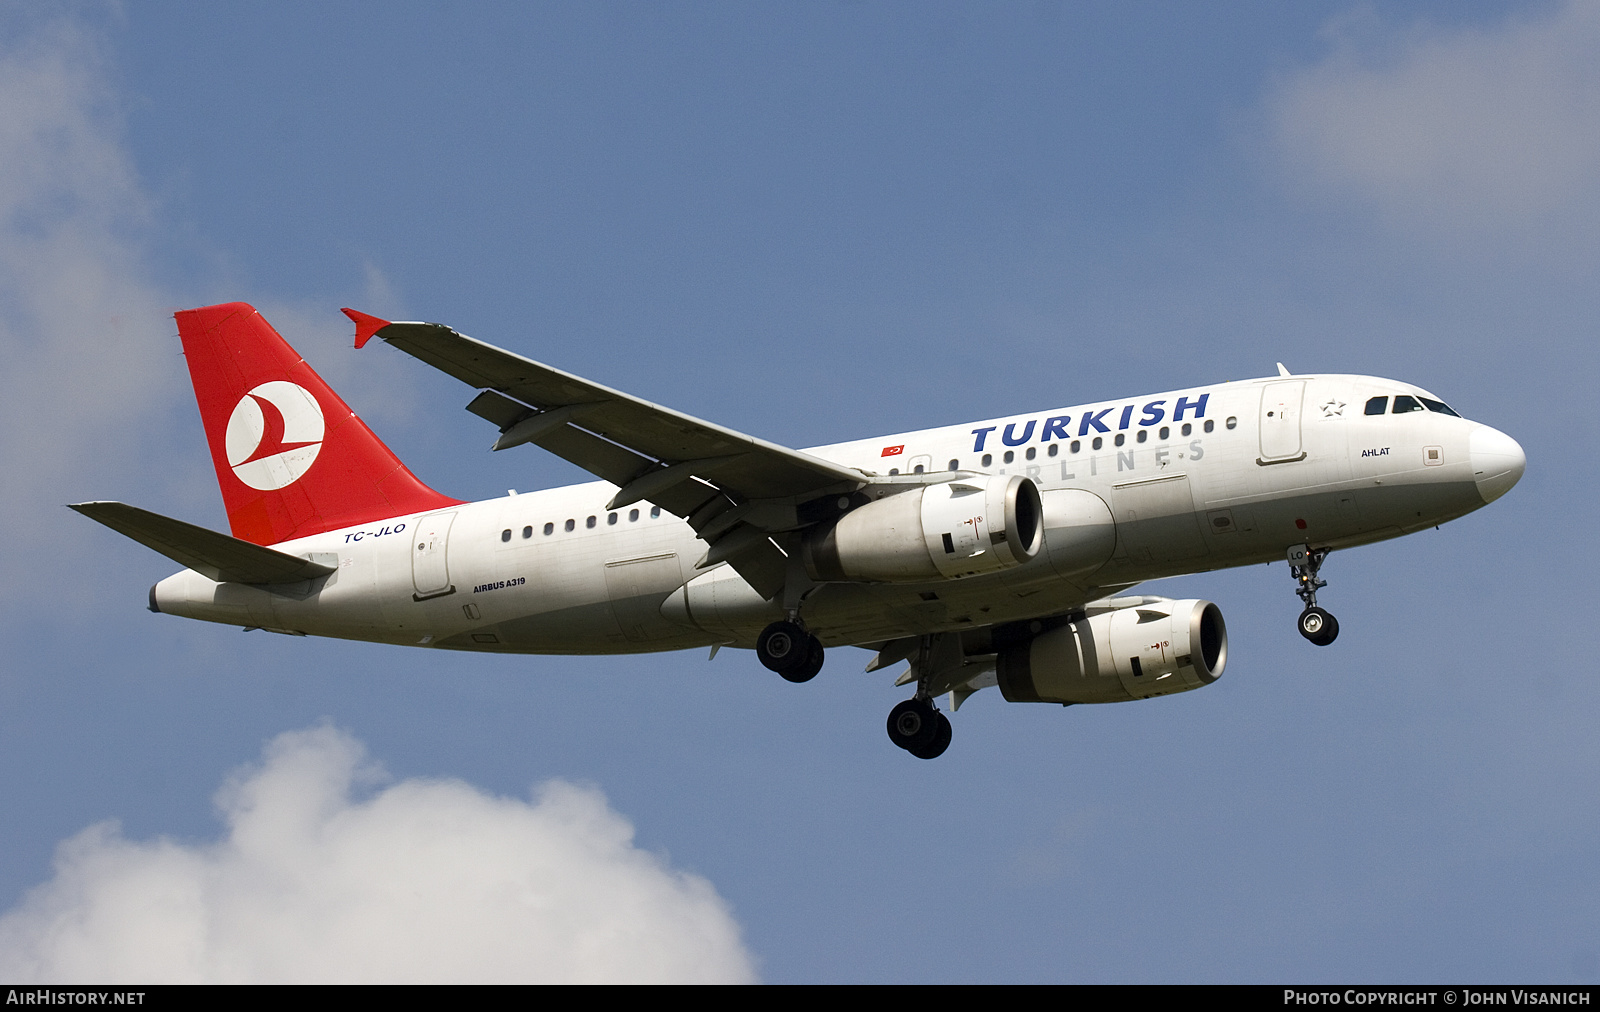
<box><xmin>178</xmin><ymin>303</ymin><xmax>459</xmax><ymax>544</ymax></box>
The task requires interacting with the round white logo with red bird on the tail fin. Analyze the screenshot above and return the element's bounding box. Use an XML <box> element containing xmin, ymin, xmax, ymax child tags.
<box><xmin>226</xmin><ymin>380</ymin><xmax>326</xmax><ymax>492</ymax></box>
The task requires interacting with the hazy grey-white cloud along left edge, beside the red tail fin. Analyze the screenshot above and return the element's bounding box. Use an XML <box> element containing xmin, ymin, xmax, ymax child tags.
<box><xmin>0</xmin><ymin>18</ymin><xmax>193</xmax><ymax>599</ymax></box>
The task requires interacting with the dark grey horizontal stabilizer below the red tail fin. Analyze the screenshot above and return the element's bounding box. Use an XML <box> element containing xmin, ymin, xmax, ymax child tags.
<box><xmin>69</xmin><ymin>503</ymin><xmax>334</xmax><ymax>584</ymax></box>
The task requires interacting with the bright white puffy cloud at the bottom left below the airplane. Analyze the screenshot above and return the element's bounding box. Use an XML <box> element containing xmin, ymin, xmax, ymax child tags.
<box><xmin>0</xmin><ymin>727</ymin><xmax>755</xmax><ymax>983</ymax></box>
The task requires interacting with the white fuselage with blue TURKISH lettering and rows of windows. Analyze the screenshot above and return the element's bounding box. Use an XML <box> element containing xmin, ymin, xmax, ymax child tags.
<box><xmin>152</xmin><ymin>376</ymin><xmax>1520</xmax><ymax>653</ymax></box>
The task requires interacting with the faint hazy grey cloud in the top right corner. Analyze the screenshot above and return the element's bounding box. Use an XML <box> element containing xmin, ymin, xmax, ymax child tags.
<box><xmin>1269</xmin><ymin>0</ymin><xmax>1600</xmax><ymax>229</ymax></box>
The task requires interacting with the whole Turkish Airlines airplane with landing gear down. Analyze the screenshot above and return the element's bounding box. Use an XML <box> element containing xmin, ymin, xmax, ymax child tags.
<box><xmin>72</xmin><ymin>303</ymin><xmax>1526</xmax><ymax>759</ymax></box>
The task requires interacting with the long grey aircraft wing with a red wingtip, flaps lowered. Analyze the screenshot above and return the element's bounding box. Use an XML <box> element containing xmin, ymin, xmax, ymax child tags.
<box><xmin>344</xmin><ymin>309</ymin><xmax>869</xmax><ymax>597</ymax></box>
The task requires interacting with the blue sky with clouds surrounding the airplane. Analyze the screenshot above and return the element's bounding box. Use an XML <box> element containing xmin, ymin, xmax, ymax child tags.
<box><xmin>0</xmin><ymin>3</ymin><xmax>1600</xmax><ymax>982</ymax></box>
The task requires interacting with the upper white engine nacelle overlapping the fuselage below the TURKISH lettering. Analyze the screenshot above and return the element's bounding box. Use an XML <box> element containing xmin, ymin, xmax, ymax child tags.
<box><xmin>802</xmin><ymin>474</ymin><xmax>1045</xmax><ymax>583</ymax></box>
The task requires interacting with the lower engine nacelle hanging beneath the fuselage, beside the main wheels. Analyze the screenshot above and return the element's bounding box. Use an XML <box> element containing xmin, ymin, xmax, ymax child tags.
<box><xmin>995</xmin><ymin>600</ymin><xmax>1227</xmax><ymax>703</ymax></box>
